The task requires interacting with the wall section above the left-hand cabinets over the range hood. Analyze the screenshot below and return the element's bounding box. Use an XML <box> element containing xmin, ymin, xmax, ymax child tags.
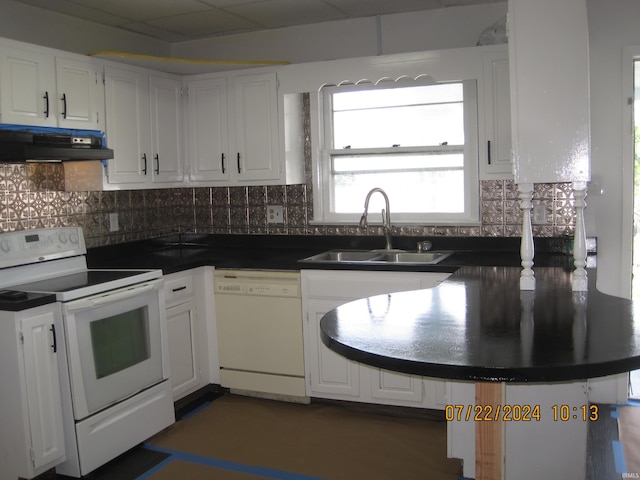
<box><xmin>0</xmin><ymin>0</ymin><xmax>170</xmax><ymax>55</ymax></box>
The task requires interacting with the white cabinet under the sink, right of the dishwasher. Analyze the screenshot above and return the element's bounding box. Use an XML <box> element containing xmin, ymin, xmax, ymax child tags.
<box><xmin>302</xmin><ymin>270</ymin><xmax>449</xmax><ymax>409</ymax></box>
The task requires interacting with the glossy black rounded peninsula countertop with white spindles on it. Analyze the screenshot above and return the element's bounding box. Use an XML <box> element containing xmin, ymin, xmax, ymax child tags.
<box><xmin>320</xmin><ymin>267</ymin><xmax>640</xmax><ymax>383</ymax></box>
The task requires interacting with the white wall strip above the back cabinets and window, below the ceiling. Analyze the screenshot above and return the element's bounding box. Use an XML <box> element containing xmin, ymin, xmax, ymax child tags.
<box><xmin>173</xmin><ymin>1</ymin><xmax>507</xmax><ymax>63</ymax></box>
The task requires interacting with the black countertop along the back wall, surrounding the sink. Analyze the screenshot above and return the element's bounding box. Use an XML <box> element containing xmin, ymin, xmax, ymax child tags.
<box><xmin>87</xmin><ymin>234</ymin><xmax>584</xmax><ymax>274</ymax></box>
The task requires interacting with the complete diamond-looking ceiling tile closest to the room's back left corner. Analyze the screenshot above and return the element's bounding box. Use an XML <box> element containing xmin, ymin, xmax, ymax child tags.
<box><xmin>145</xmin><ymin>10</ymin><xmax>259</xmax><ymax>38</ymax></box>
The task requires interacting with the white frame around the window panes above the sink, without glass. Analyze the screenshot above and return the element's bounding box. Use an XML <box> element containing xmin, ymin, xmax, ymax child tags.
<box><xmin>311</xmin><ymin>76</ymin><xmax>480</xmax><ymax>225</ymax></box>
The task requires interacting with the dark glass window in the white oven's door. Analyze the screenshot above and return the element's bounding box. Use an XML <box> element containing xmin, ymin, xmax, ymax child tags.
<box><xmin>90</xmin><ymin>307</ymin><xmax>150</xmax><ymax>379</ymax></box>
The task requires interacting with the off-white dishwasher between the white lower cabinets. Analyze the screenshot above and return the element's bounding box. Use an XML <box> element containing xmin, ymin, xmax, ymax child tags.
<box><xmin>214</xmin><ymin>269</ymin><xmax>307</xmax><ymax>401</ymax></box>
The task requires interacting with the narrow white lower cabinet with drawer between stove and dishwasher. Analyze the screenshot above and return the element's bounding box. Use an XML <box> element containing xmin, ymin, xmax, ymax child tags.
<box><xmin>164</xmin><ymin>268</ymin><xmax>215</xmax><ymax>401</ymax></box>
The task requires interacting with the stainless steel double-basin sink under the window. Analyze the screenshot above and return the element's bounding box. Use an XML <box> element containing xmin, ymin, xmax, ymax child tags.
<box><xmin>302</xmin><ymin>250</ymin><xmax>454</xmax><ymax>265</ymax></box>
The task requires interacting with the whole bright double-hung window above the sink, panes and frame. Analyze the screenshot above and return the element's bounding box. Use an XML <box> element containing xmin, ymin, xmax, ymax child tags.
<box><xmin>314</xmin><ymin>80</ymin><xmax>479</xmax><ymax>224</ymax></box>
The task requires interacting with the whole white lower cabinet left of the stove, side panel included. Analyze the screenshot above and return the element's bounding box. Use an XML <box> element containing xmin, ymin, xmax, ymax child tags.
<box><xmin>0</xmin><ymin>303</ymin><xmax>66</xmax><ymax>479</ymax></box>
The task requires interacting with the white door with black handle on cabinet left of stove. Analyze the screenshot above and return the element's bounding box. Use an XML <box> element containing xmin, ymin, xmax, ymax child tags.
<box><xmin>21</xmin><ymin>312</ymin><xmax>65</xmax><ymax>470</ymax></box>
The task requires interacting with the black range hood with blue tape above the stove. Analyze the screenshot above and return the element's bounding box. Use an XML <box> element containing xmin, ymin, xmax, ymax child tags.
<box><xmin>0</xmin><ymin>127</ymin><xmax>113</xmax><ymax>163</ymax></box>
